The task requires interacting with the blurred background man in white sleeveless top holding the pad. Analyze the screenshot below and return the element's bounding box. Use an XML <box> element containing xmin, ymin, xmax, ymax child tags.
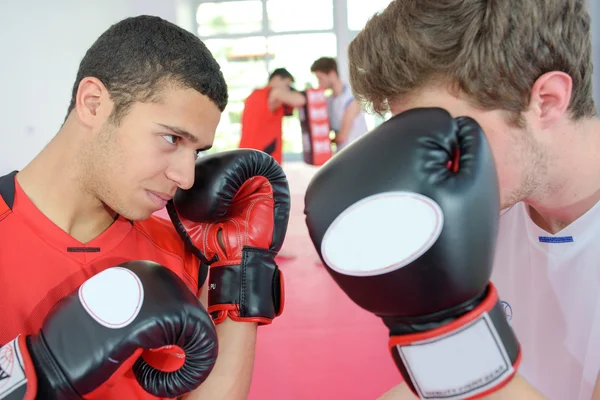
<box><xmin>310</xmin><ymin>57</ymin><xmax>367</xmax><ymax>152</ymax></box>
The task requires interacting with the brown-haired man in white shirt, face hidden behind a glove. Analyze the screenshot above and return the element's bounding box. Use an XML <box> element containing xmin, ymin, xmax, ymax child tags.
<box><xmin>348</xmin><ymin>0</ymin><xmax>600</xmax><ymax>400</ymax></box>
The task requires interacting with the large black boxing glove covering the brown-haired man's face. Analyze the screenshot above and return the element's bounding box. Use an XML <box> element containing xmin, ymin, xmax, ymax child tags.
<box><xmin>305</xmin><ymin>109</ymin><xmax>520</xmax><ymax>399</ymax></box>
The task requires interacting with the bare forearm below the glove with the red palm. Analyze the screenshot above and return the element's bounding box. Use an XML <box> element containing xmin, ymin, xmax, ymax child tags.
<box><xmin>185</xmin><ymin>318</ymin><xmax>257</xmax><ymax>400</ymax></box>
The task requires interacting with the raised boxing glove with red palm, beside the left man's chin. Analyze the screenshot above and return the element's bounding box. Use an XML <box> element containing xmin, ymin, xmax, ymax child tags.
<box><xmin>167</xmin><ymin>149</ymin><xmax>290</xmax><ymax>325</ymax></box>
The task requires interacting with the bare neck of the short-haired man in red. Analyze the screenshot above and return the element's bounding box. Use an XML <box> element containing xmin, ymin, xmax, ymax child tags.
<box><xmin>16</xmin><ymin>122</ymin><xmax>115</xmax><ymax>243</ymax></box>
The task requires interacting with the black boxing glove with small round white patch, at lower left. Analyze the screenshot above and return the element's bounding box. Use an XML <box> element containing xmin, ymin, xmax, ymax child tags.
<box><xmin>0</xmin><ymin>261</ymin><xmax>218</xmax><ymax>400</ymax></box>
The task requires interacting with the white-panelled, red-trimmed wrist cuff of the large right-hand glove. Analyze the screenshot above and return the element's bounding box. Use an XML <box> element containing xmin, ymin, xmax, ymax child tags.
<box><xmin>389</xmin><ymin>284</ymin><xmax>521</xmax><ymax>400</ymax></box>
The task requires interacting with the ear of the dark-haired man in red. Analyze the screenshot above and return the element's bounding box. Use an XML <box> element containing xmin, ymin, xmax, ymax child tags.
<box><xmin>75</xmin><ymin>77</ymin><xmax>113</xmax><ymax>127</ymax></box>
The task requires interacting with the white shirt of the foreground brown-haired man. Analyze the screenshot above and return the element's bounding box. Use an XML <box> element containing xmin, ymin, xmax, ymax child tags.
<box><xmin>492</xmin><ymin>203</ymin><xmax>600</xmax><ymax>400</ymax></box>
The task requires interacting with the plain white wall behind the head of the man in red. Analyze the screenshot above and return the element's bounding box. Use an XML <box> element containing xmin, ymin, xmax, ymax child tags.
<box><xmin>0</xmin><ymin>0</ymin><xmax>189</xmax><ymax>175</ymax></box>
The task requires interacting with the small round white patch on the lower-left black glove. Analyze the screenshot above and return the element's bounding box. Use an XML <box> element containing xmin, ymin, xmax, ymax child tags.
<box><xmin>79</xmin><ymin>267</ymin><xmax>144</xmax><ymax>329</ymax></box>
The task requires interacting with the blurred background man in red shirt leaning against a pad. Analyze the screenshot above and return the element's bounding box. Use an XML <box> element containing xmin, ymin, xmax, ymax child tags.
<box><xmin>240</xmin><ymin>68</ymin><xmax>306</xmax><ymax>164</ymax></box>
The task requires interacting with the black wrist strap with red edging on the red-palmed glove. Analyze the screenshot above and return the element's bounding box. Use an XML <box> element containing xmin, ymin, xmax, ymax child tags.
<box><xmin>208</xmin><ymin>247</ymin><xmax>284</xmax><ymax>325</ymax></box>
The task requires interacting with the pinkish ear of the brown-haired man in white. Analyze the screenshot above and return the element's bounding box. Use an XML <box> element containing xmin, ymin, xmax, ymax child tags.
<box><xmin>529</xmin><ymin>71</ymin><xmax>573</xmax><ymax>128</ymax></box>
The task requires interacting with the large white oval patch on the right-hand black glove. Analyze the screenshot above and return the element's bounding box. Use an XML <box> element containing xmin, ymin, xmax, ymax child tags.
<box><xmin>321</xmin><ymin>192</ymin><xmax>444</xmax><ymax>276</ymax></box>
